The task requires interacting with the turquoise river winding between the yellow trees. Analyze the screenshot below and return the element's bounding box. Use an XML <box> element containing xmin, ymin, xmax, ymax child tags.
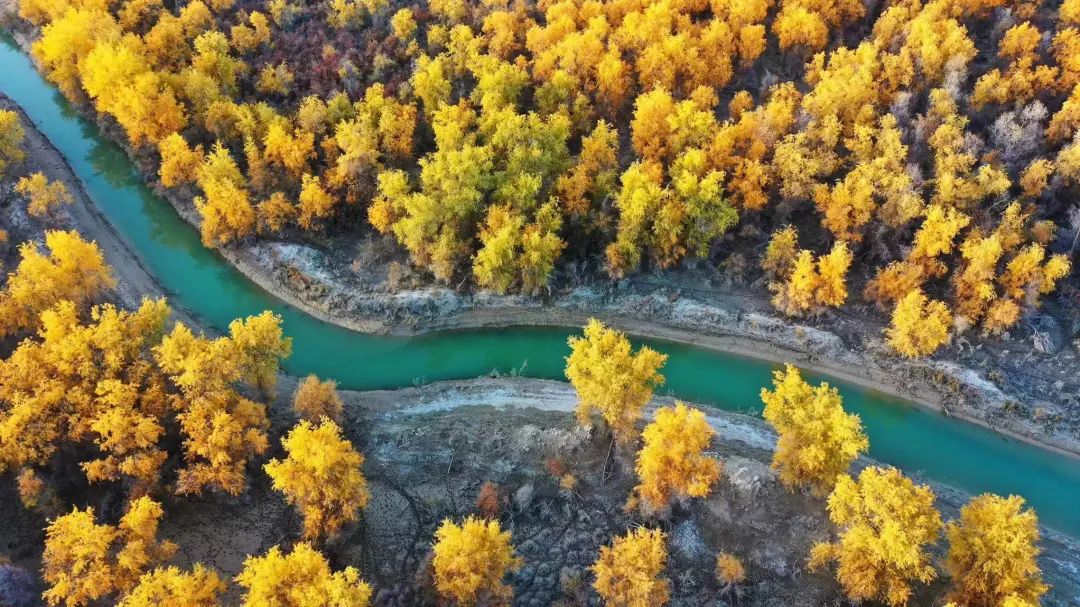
<box><xmin>0</xmin><ymin>37</ymin><xmax>1080</xmax><ymax>537</ymax></box>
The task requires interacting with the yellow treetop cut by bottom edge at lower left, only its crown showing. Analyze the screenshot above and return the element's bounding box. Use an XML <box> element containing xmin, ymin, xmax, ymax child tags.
<box><xmin>117</xmin><ymin>563</ymin><xmax>225</xmax><ymax>607</ymax></box>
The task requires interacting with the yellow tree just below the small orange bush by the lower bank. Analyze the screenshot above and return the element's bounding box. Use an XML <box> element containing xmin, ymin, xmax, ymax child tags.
<box><xmin>264</xmin><ymin>418</ymin><xmax>370</xmax><ymax>540</ymax></box>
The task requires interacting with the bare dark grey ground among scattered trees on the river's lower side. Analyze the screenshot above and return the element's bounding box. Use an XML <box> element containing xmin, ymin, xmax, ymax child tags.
<box><xmin>0</xmin><ymin>377</ymin><xmax>1080</xmax><ymax>607</ymax></box>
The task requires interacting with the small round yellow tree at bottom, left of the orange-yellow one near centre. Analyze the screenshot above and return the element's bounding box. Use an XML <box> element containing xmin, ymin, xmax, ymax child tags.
<box><xmin>431</xmin><ymin>516</ymin><xmax>522</xmax><ymax>605</ymax></box>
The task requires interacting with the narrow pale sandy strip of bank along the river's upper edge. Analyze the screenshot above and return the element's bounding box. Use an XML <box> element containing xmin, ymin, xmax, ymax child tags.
<box><xmin>232</xmin><ymin>239</ymin><xmax>1080</xmax><ymax>458</ymax></box>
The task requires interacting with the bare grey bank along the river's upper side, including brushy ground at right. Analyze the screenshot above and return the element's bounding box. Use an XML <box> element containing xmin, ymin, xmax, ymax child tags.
<box><xmin>0</xmin><ymin>14</ymin><xmax>1080</xmax><ymax>456</ymax></box>
